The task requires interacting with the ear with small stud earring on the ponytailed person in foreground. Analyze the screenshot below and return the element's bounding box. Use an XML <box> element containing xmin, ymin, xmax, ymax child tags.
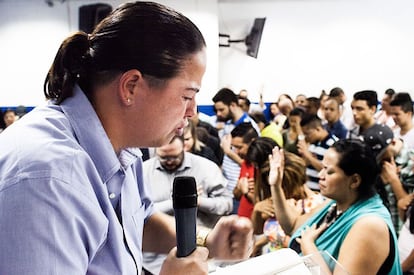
<box><xmin>119</xmin><ymin>69</ymin><xmax>142</xmax><ymax>106</ymax></box>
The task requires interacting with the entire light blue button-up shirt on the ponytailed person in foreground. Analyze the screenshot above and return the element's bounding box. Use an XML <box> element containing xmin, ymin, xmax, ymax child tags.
<box><xmin>0</xmin><ymin>85</ymin><xmax>153</xmax><ymax>275</ymax></box>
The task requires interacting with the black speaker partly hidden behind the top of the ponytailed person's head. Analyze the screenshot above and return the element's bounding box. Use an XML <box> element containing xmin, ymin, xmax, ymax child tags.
<box><xmin>79</xmin><ymin>3</ymin><xmax>112</xmax><ymax>33</ymax></box>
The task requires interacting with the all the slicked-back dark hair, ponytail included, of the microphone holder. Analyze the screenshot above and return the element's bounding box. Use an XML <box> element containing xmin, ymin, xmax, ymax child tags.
<box><xmin>44</xmin><ymin>1</ymin><xmax>206</xmax><ymax>104</ymax></box>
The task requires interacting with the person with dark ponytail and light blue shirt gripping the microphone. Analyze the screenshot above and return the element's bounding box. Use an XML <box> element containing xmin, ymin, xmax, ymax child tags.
<box><xmin>0</xmin><ymin>1</ymin><xmax>252</xmax><ymax>275</ymax></box>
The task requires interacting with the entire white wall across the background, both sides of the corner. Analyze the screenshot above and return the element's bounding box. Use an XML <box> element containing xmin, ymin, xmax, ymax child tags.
<box><xmin>0</xmin><ymin>0</ymin><xmax>414</xmax><ymax>106</ymax></box>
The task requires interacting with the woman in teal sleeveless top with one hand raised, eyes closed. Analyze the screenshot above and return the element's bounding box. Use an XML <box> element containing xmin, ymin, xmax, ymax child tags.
<box><xmin>269</xmin><ymin>140</ymin><xmax>402</xmax><ymax>275</ymax></box>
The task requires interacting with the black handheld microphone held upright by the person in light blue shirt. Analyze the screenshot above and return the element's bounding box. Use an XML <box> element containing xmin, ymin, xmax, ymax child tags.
<box><xmin>172</xmin><ymin>177</ymin><xmax>197</xmax><ymax>257</ymax></box>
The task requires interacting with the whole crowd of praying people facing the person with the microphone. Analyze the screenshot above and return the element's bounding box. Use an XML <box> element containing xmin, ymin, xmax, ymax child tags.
<box><xmin>0</xmin><ymin>87</ymin><xmax>414</xmax><ymax>274</ymax></box>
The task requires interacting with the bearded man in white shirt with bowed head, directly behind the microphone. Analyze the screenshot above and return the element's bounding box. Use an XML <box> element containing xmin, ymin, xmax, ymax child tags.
<box><xmin>143</xmin><ymin>136</ymin><xmax>232</xmax><ymax>274</ymax></box>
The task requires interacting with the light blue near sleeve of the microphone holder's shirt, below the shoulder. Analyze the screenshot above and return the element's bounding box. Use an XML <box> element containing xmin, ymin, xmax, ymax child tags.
<box><xmin>0</xmin><ymin>177</ymin><xmax>108</xmax><ymax>275</ymax></box>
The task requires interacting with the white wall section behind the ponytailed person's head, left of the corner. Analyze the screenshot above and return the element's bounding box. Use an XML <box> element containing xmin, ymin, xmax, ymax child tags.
<box><xmin>0</xmin><ymin>0</ymin><xmax>218</xmax><ymax>107</ymax></box>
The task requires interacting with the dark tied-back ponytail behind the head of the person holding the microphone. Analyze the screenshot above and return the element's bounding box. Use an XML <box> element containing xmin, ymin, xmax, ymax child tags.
<box><xmin>43</xmin><ymin>32</ymin><xmax>89</xmax><ymax>104</ymax></box>
